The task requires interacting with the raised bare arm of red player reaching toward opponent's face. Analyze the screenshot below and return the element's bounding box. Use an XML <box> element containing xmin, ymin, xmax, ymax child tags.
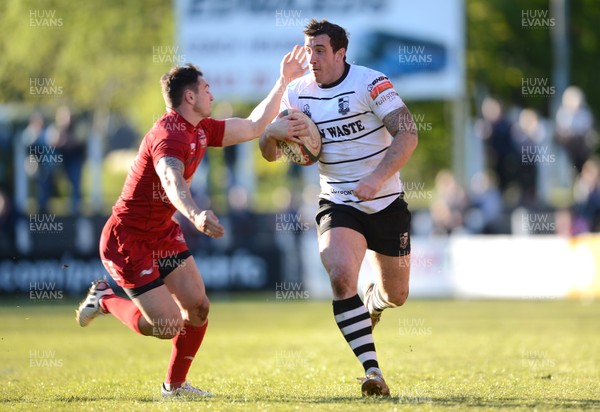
<box><xmin>223</xmin><ymin>45</ymin><xmax>307</xmax><ymax>146</ymax></box>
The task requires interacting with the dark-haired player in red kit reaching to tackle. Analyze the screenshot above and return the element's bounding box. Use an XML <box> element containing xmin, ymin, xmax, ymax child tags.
<box><xmin>76</xmin><ymin>46</ymin><xmax>306</xmax><ymax>397</ymax></box>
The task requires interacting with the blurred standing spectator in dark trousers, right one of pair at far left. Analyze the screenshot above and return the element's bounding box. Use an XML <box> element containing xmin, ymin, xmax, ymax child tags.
<box><xmin>48</xmin><ymin>106</ymin><xmax>88</xmax><ymax>215</ymax></box>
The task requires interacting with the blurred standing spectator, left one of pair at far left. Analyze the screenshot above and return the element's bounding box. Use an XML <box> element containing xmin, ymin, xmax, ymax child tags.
<box><xmin>21</xmin><ymin>112</ymin><xmax>55</xmax><ymax>213</ymax></box>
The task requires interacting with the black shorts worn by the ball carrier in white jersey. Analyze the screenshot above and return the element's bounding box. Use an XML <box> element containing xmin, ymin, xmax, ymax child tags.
<box><xmin>316</xmin><ymin>195</ymin><xmax>411</xmax><ymax>256</ymax></box>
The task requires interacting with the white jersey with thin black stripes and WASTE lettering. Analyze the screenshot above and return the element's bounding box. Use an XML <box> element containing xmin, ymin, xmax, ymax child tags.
<box><xmin>281</xmin><ymin>65</ymin><xmax>404</xmax><ymax>213</ymax></box>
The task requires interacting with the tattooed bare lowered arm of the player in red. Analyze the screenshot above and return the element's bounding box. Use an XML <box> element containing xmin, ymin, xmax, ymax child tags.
<box><xmin>155</xmin><ymin>156</ymin><xmax>225</xmax><ymax>238</ymax></box>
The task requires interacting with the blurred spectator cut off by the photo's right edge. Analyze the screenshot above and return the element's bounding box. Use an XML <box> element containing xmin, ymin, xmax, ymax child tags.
<box><xmin>572</xmin><ymin>159</ymin><xmax>600</xmax><ymax>234</ymax></box>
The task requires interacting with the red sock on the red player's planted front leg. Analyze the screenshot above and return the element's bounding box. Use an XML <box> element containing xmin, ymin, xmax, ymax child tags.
<box><xmin>165</xmin><ymin>322</ymin><xmax>208</xmax><ymax>389</ymax></box>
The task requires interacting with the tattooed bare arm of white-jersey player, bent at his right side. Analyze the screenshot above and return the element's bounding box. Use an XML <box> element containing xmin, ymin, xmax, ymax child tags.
<box><xmin>354</xmin><ymin>106</ymin><xmax>419</xmax><ymax>200</ymax></box>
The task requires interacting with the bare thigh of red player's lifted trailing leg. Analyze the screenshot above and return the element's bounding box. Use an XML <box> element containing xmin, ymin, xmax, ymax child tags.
<box><xmin>132</xmin><ymin>285</ymin><xmax>183</xmax><ymax>330</ymax></box>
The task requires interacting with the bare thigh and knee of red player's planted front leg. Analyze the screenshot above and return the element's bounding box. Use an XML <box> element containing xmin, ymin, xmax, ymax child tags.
<box><xmin>164</xmin><ymin>256</ymin><xmax>210</xmax><ymax>323</ymax></box>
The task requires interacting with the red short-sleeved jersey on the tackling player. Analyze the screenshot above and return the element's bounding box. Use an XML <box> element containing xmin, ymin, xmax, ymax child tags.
<box><xmin>113</xmin><ymin>109</ymin><xmax>225</xmax><ymax>234</ymax></box>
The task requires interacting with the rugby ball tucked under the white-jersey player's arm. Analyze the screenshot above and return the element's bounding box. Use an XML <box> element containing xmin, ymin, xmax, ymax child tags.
<box><xmin>277</xmin><ymin>109</ymin><xmax>321</xmax><ymax>166</ymax></box>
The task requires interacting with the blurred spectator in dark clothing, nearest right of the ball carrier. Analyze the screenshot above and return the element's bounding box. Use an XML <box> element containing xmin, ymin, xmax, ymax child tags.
<box><xmin>475</xmin><ymin>97</ymin><xmax>520</xmax><ymax>192</ymax></box>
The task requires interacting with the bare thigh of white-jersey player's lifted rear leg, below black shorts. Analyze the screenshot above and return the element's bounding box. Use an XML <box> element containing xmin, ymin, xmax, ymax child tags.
<box><xmin>367</xmin><ymin>250</ymin><xmax>410</xmax><ymax>305</ymax></box>
